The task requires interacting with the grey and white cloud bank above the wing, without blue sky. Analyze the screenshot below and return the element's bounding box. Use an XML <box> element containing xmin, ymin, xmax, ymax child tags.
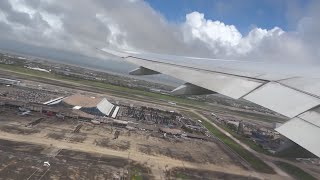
<box><xmin>0</xmin><ymin>0</ymin><xmax>320</xmax><ymax>63</ymax></box>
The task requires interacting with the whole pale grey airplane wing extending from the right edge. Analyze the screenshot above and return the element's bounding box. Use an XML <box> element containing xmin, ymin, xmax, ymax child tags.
<box><xmin>102</xmin><ymin>49</ymin><xmax>320</xmax><ymax>157</ymax></box>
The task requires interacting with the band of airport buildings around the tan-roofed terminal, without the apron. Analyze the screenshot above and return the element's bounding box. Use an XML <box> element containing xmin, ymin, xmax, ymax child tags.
<box><xmin>0</xmin><ymin>76</ymin><xmax>215</xmax><ymax>143</ymax></box>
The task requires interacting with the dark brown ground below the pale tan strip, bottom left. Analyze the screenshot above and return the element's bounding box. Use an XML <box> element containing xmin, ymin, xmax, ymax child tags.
<box><xmin>0</xmin><ymin>140</ymin><xmax>153</xmax><ymax>180</ymax></box>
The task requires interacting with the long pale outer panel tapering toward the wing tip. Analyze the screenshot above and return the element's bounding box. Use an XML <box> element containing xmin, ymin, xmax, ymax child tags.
<box><xmin>126</xmin><ymin>56</ymin><xmax>264</xmax><ymax>99</ymax></box>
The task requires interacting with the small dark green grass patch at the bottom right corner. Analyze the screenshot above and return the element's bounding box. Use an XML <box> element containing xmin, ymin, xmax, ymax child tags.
<box><xmin>276</xmin><ymin>161</ymin><xmax>316</xmax><ymax>180</ymax></box>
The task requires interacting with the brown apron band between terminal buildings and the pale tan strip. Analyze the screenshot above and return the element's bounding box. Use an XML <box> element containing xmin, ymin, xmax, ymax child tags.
<box><xmin>0</xmin><ymin>110</ymin><xmax>237</xmax><ymax>166</ymax></box>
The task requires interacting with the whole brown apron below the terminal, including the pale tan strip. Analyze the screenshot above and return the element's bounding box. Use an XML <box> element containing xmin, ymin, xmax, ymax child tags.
<box><xmin>0</xmin><ymin>107</ymin><xmax>276</xmax><ymax>179</ymax></box>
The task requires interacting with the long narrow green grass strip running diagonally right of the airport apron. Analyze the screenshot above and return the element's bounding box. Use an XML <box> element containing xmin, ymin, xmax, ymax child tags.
<box><xmin>185</xmin><ymin>112</ymin><xmax>275</xmax><ymax>174</ymax></box>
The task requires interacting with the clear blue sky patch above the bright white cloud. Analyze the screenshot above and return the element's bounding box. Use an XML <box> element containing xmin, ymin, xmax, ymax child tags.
<box><xmin>146</xmin><ymin>0</ymin><xmax>310</xmax><ymax>34</ymax></box>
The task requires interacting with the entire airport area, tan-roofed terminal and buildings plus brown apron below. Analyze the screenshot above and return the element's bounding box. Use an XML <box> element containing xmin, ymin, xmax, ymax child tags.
<box><xmin>0</xmin><ymin>81</ymin><xmax>264</xmax><ymax>179</ymax></box>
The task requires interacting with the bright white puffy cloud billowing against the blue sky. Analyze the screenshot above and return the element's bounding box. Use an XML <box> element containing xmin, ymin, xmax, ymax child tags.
<box><xmin>184</xmin><ymin>12</ymin><xmax>285</xmax><ymax>56</ymax></box>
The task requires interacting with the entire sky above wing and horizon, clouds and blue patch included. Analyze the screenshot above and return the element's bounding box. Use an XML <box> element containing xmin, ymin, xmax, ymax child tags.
<box><xmin>0</xmin><ymin>0</ymin><xmax>320</xmax><ymax>64</ymax></box>
